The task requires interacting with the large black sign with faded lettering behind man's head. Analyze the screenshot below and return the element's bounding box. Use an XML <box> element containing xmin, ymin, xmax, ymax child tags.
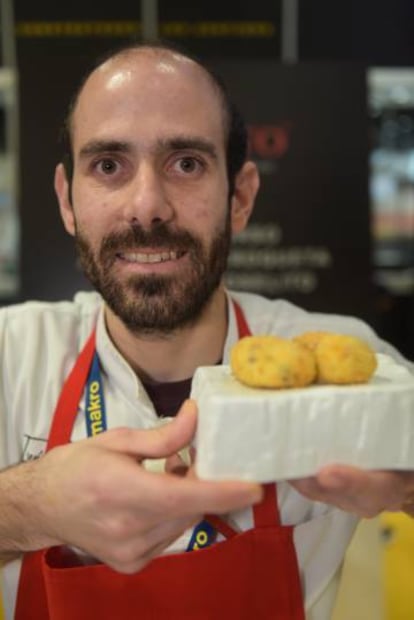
<box><xmin>212</xmin><ymin>62</ymin><xmax>372</xmax><ymax>317</ymax></box>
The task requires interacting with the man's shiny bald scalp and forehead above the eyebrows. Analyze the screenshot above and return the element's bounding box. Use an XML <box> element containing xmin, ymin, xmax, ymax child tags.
<box><xmin>72</xmin><ymin>48</ymin><xmax>227</xmax><ymax>144</ymax></box>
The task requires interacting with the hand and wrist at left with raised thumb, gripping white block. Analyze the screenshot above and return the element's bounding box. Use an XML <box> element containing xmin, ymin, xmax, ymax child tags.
<box><xmin>0</xmin><ymin>401</ymin><xmax>262</xmax><ymax>573</ymax></box>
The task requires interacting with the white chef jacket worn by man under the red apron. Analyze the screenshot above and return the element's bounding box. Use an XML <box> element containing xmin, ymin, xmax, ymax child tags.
<box><xmin>0</xmin><ymin>292</ymin><xmax>413</xmax><ymax>620</ymax></box>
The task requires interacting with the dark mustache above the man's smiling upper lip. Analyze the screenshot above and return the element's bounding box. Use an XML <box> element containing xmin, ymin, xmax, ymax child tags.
<box><xmin>99</xmin><ymin>223</ymin><xmax>201</xmax><ymax>259</ymax></box>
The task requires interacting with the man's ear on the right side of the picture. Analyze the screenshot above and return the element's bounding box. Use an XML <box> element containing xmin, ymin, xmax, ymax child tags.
<box><xmin>230</xmin><ymin>161</ymin><xmax>260</xmax><ymax>234</ymax></box>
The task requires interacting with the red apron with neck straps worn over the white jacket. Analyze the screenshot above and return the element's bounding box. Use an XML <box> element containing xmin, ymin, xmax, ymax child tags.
<box><xmin>15</xmin><ymin>304</ymin><xmax>305</xmax><ymax>620</ymax></box>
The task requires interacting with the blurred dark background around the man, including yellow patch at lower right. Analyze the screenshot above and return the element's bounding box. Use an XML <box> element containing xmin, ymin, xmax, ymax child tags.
<box><xmin>0</xmin><ymin>0</ymin><xmax>414</xmax><ymax>620</ymax></box>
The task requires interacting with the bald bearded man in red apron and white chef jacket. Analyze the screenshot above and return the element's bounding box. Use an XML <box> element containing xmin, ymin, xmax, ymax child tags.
<box><xmin>0</xmin><ymin>46</ymin><xmax>414</xmax><ymax>620</ymax></box>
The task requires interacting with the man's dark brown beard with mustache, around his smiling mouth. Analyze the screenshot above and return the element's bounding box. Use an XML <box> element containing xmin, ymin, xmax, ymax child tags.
<box><xmin>76</xmin><ymin>215</ymin><xmax>231</xmax><ymax>334</ymax></box>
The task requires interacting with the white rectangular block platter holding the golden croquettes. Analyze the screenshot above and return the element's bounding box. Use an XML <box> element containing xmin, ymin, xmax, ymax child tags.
<box><xmin>192</xmin><ymin>354</ymin><xmax>414</xmax><ymax>482</ymax></box>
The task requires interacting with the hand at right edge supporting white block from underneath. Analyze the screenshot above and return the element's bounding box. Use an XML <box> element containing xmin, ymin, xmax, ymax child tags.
<box><xmin>290</xmin><ymin>465</ymin><xmax>414</xmax><ymax>517</ymax></box>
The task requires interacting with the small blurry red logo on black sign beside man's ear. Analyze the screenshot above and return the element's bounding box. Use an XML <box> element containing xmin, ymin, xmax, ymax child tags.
<box><xmin>247</xmin><ymin>121</ymin><xmax>292</xmax><ymax>160</ymax></box>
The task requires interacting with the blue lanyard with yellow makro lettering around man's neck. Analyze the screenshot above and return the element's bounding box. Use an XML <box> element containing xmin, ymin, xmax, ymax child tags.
<box><xmin>85</xmin><ymin>351</ymin><xmax>216</xmax><ymax>551</ymax></box>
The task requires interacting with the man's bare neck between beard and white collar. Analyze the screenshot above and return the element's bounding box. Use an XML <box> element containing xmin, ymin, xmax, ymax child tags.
<box><xmin>105</xmin><ymin>287</ymin><xmax>227</xmax><ymax>382</ymax></box>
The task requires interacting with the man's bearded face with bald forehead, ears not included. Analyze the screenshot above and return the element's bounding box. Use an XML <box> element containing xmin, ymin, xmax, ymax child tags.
<box><xmin>65</xmin><ymin>52</ymin><xmax>231</xmax><ymax>333</ymax></box>
